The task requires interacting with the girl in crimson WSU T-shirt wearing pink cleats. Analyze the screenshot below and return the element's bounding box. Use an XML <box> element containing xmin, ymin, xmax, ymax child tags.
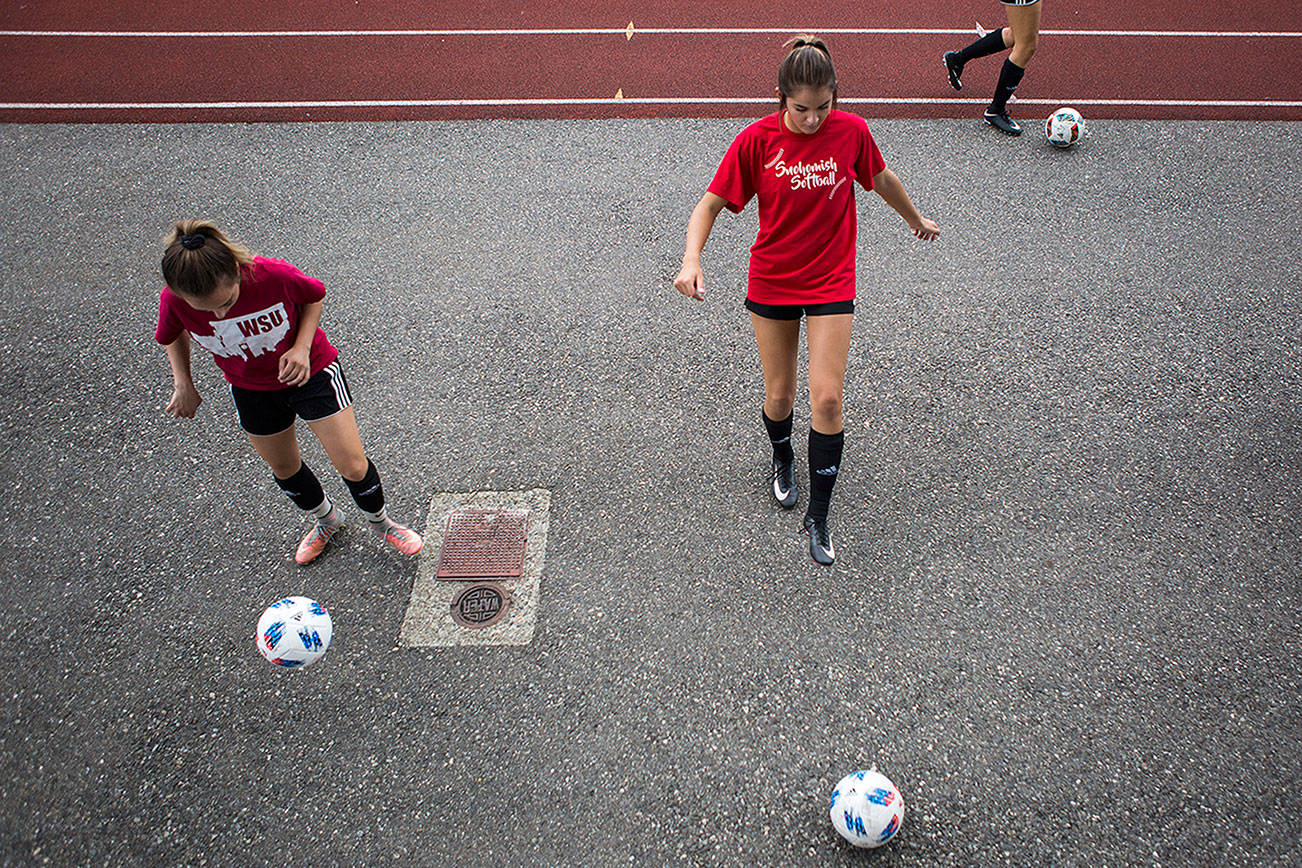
<box><xmin>154</xmin><ymin>220</ymin><xmax>423</xmax><ymax>563</ymax></box>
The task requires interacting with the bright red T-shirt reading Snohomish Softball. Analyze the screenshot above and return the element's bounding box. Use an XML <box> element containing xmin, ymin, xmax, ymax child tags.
<box><xmin>708</xmin><ymin>109</ymin><xmax>885</xmax><ymax>305</ymax></box>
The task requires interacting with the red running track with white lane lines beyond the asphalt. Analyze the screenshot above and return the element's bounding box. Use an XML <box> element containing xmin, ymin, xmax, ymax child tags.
<box><xmin>0</xmin><ymin>0</ymin><xmax>1302</xmax><ymax>122</ymax></box>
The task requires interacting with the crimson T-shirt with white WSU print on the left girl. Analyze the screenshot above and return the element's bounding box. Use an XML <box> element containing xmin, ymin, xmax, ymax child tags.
<box><xmin>154</xmin><ymin>256</ymin><xmax>339</xmax><ymax>392</ymax></box>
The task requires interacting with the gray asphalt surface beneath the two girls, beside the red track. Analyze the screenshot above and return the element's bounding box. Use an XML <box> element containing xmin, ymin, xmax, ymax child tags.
<box><xmin>0</xmin><ymin>118</ymin><xmax>1302</xmax><ymax>865</ymax></box>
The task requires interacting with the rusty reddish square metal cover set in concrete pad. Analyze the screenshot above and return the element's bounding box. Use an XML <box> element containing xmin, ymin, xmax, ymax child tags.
<box><xmin>436</xmin><ymin>509</ymin><xmax>529</xmax><ymax>579</ymax></box>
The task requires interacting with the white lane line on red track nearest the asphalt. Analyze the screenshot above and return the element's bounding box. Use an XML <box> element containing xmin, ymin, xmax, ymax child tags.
<box><xmin>0</xmin><ymin>96</ymin><xmax>1302</xmax><ymax>111</ymax></box>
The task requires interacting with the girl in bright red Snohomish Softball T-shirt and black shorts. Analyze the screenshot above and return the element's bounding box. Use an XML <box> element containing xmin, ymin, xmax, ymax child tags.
<box><xmin>673</xmin><ymin>36</ymin><xmax>940</xmax><ymax>566</ymax></box>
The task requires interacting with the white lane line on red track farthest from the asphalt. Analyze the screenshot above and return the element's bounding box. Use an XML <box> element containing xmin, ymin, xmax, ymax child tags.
<box><xmin>0</xmin><ymin>27</ymin><xmax>1302</xmax><ymax>39</ymax></box>
